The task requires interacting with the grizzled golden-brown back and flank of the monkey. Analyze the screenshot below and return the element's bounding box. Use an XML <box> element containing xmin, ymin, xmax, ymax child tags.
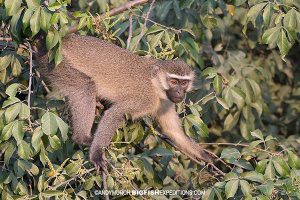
<box><xmin>54</xmin><ymin>34</ymin><xmax>154</xmax><ymax>100</ymax></box>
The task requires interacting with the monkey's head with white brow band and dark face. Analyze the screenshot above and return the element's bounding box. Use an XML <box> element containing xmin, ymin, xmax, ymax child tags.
<box><xmin>155</xmin><ymin>59</ymin><xmax>194</xmax><ymax>103</ymax></box>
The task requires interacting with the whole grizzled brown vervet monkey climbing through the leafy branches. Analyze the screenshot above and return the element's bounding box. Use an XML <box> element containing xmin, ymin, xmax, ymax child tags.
<box><xmin>36</xmin><ymin>34</ymin><xmax>210</xmax><ymax>166</ymax></box>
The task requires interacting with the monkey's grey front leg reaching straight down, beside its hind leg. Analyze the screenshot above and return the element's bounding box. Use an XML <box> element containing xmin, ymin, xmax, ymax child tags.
<box><xmin>90</xmin><ymin>105</ymin><xmax>124</xmax><ymax>170</ymax></box>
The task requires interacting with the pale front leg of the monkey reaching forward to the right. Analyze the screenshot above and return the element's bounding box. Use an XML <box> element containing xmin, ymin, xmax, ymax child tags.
<box><xmin>156</xmin><ymin>105</ymin><xmax>211</xmax><ymax>162</ymax></box>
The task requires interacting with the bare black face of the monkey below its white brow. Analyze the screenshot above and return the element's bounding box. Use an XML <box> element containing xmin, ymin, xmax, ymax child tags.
<box><xmin>166</xmin><ymin>78</ymin><xmax>190</xmax><ymax>103</ymax></box>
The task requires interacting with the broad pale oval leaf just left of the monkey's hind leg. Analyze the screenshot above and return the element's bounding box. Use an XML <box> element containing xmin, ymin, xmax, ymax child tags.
<box><xmin>41</xmin><ymin>112</ymin><xmax>58</xmax><ymax>135</ymax></box>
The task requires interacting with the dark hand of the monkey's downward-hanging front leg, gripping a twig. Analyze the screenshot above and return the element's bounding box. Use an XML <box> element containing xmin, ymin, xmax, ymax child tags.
<box><xmin>90</xmin><ymin>147</ymin><xmax>108</xmax><ymax>174</ymax></box>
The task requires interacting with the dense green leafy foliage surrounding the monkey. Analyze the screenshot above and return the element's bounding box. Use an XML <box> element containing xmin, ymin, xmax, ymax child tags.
<box><xmin>0</xmin><ymin>0</ymin><xmax>300</xmax><ymax>199</ymax></box>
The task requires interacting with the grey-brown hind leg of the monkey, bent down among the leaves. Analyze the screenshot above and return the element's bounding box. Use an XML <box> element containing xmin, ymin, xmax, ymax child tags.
<box><xmin>67</xmin><ymin>82</ymin><xmax>96</xmax><ymax>145</ymax></box>
